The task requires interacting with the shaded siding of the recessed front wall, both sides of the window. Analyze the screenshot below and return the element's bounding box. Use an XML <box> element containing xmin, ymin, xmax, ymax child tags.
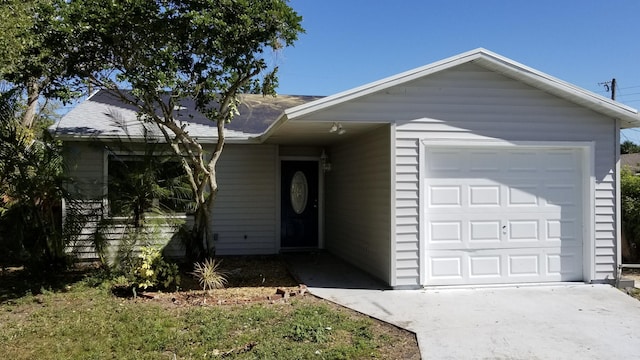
<box><xmin>65</xmin><ymin>142</ymin><xmax>278</xmax><ymax>259</ymax></box>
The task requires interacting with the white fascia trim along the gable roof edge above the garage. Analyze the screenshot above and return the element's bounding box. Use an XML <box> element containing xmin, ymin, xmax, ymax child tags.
<box><xmin>276</xmin><ymin>48</ymin><xmax>640</xmax><ymax>132</ymax></box>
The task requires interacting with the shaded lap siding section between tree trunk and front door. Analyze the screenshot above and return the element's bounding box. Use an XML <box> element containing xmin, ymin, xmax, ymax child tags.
<box><xmin>213</xmin><ymin>145</ymin><xmax>278</xmax><ymax>255</ymax></box>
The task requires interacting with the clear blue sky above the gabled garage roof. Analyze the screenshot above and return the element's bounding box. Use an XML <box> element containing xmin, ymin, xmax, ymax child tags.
<box><xmin>272</xmin><ymin>0</ymin><xmax>640</xmax><ymax>143</ymax></box>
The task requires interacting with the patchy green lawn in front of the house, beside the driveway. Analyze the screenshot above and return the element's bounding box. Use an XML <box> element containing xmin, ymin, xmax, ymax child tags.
<box><xmin>0</xmin><ymin>258</ymin><xmax>419</xmax><ymax>359</ymax></box>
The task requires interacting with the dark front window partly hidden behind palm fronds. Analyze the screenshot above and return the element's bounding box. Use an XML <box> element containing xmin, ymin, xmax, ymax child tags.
<box><xmin>107</xmin><ymin>153</ymin><xmax>193</xmax><ymax>217</ymax></box>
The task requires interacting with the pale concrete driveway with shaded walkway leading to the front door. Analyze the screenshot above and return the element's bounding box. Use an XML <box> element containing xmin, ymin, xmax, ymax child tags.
<box><xmin>286</xmin><ymin>252</ymin><xmax>640</xmax><ymax>359</ymax></box>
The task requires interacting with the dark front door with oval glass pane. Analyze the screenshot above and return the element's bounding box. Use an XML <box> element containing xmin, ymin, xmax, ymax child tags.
<box><xmin>280</xmin><ymin>161</ymin><xmax>318</xmax><ymax>248</ymax></box>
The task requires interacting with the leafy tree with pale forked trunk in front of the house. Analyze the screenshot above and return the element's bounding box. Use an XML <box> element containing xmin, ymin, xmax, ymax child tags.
<box><xmin>0</xmin><ymin>0</ymin><xmax>303</xmax><ymax>256</ymax></box>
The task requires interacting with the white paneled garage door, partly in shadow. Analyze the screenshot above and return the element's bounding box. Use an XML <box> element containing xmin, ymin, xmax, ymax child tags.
<box><xmin>423</xmin><ymin>147</ymin><xmax>583</xmax><ymax>285</ymax></box>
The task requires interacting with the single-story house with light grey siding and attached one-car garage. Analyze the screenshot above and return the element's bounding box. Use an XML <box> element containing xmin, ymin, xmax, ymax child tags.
<box><xmin>53</xmin><ymin>49</ymin><xmax>640</xmax><ymax>288</ymax></box>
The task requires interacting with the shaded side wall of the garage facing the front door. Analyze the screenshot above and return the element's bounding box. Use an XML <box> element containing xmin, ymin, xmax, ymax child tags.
<box><xmin>325</xmin><ymin>126</ymin><xmax>391</xmax><ymax>283</ymax></box>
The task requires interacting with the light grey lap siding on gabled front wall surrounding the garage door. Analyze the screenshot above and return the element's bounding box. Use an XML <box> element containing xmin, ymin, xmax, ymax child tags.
<box><xmin>323</xmin><ymin>63</ymin><xmax>617</xmax><ymax>286</ymax></box>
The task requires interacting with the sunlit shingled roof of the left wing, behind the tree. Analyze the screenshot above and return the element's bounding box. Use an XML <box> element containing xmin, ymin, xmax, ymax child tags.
<box><xmin>50</xmin><ymin>90</ymin><xmax>319</xmax><ymax>142</ymax></box>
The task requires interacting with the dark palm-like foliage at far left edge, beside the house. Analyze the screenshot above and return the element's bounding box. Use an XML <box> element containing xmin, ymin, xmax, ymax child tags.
<box><xmin>0</xmin><ymin>88</ymin><xmax>68</xmax><ymax>264</ymax></box>
